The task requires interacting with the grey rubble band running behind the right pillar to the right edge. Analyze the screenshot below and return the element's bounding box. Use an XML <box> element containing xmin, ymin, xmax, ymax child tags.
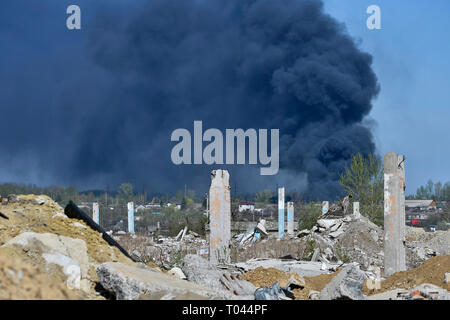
<box><xmin>233</xmin><ymin>215</ymin><xmax>450</xmax><ymax>270</ymax></box>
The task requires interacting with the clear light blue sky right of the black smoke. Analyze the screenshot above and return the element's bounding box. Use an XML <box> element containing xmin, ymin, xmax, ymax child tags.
<box><xmin>325</xmin><ymin>0</ymin><xmax>450</xmax><ymax>194</ymax></box>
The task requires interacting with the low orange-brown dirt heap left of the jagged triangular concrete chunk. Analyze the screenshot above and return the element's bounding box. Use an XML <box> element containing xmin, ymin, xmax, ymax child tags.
<box><xmin>240</xmin><ymin>267</ymin><xmax>339</xmax><ymax>300</ymax></box>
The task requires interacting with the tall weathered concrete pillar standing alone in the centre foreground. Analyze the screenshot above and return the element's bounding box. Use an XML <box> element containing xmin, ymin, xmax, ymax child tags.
<box><xmin>209</xmin><ymin>170</ymin><xmax>231</xmax><ymax>264</ymax></box>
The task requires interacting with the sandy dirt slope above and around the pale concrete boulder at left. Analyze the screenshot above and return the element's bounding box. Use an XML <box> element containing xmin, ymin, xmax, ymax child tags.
<box><xmin>0</xmin><ymin>195</ymin><xmax>134</xmax><ymax>298</ymax></box>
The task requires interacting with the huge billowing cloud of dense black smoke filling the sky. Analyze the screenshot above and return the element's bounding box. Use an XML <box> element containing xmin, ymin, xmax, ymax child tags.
<box><xmin>0</xmin><ymin>0</ymin><xmax>378</xmax><ymax>198</ymax></box>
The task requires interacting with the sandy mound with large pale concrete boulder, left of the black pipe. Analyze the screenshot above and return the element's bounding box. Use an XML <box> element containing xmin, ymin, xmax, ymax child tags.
<box><xmin>0</xmin><ymin>195</ymin><xmax>133</xmax><ymax>299</ymax></box>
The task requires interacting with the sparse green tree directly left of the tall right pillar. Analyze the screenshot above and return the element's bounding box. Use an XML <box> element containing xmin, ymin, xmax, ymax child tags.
<box><xmin>339</xmin><ymin>153</ymin><xmax>384</xmax><ymax>226</ymax></box>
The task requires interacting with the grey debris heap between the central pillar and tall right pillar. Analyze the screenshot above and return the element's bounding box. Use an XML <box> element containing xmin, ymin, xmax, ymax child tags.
<box><xmin>235</xmin><ymin>215</ymin><xmax>384</xmax><ymax>270</ymax></box>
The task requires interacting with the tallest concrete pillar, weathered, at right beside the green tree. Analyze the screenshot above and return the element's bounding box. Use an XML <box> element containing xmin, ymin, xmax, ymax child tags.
<box><xmin>384</xmin><ymin>152</ymin><xmax>406</xmax><ymax>277</ymax></box>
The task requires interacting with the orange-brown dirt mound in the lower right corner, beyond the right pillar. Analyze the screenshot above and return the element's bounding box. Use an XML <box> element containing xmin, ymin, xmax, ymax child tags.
<box><xmin>363</xmin><ymin>255</ymin><xmax>450</xmax><ymax>295</ymax></box>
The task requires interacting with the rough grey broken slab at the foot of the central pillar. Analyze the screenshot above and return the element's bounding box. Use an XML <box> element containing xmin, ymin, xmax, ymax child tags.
<box><xmin>182</xmin><ymin>254</ymin><xmax>257</xmax><ymax>296</ymax></box>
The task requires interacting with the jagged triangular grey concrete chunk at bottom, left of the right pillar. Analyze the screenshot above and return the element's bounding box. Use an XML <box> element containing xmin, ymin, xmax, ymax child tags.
<box><xmin>319</xmin><ymin>264</ymin><xmax>367</xmax><ymax>300</ymax></box>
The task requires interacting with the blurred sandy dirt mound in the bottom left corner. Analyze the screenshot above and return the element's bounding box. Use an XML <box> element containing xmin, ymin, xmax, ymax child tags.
<box><xmin>0</xmin><ymin>249</ymin><xmax>80</xmax><ymax>300</ymax></box>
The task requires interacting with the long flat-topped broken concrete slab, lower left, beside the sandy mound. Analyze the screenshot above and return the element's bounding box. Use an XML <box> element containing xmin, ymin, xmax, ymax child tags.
<box><xmin>97</xmin><ymin>262</ymin><xmax>227</xmax><ymax>300</ymax></box>
